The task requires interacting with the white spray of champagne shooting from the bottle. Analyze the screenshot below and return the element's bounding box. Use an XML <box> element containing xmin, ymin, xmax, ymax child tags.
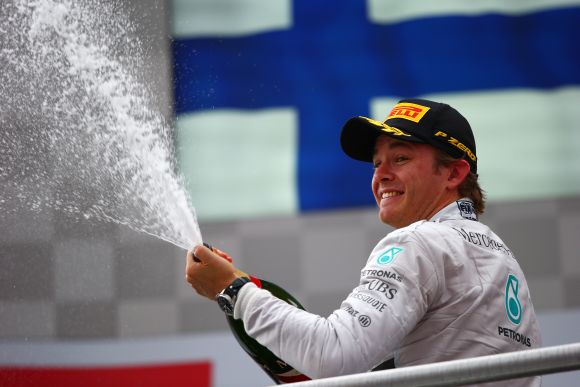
<box><xmin>0</xmin><ymin>0</ymin><xmax>202</xmax><ymax>249</ymax></box>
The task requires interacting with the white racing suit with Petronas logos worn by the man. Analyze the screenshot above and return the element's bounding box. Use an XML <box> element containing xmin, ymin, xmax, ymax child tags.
<box><xmin>234</xmin><ymin>199</ymin><xmax>541</xmax><ymax>386</ymax></box>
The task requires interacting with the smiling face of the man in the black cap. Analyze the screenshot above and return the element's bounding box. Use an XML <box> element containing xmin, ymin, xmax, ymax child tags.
<box><xmin>372</xmin><ymin>136</ymin><xmax>455</xmax><ymax>228</ymax></box>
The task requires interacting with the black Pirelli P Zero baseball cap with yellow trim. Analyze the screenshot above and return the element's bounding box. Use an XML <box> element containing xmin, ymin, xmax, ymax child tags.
<box><xmin>340</xmin><ymin>98</ymin><xmax>477</xmax><ymax>173</ymax></box>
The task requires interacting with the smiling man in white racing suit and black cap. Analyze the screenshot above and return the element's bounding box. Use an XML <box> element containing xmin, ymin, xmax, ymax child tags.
<box><xmin>186</xmin><ymin>99</ymin><xmax>541</xmax><ymax>386</ymax></box>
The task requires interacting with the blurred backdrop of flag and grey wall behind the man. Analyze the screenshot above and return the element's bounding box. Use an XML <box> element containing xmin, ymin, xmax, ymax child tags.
<box><xmin>0</xmin><ymin>0</ymin><xmax>580</xmax><ymax>387</ymax></box>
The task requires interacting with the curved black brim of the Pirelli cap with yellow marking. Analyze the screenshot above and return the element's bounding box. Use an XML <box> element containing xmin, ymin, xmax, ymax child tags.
<box><xmin>340</xmin><ymin>116</ymin><xmax>425</xmax><ymax>162</ymax></box>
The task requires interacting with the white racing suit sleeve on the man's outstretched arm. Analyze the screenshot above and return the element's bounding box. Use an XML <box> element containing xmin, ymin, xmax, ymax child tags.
<box><xmin>234</xmin><ymin>232</ymin><xmax>439</xmax><ymax>378</ymax></box>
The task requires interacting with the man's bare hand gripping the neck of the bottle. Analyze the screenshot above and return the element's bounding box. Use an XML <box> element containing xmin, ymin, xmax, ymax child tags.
<box><xmin>185</xmin><ymin>245</ymin><xmax>241</xmax><ymax>300</ymax></box>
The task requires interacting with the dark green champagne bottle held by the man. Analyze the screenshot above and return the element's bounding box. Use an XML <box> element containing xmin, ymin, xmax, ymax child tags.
<box><xmin>206</xmin><ymin>244</ymin><xmax>310</xmax><ymax>384</ymax></box>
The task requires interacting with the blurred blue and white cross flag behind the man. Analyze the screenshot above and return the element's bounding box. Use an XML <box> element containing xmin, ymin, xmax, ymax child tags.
<box><xmin>171</xmin><ymin>0</ymin><xmax>580</xmax><ymax>219</ymax></box>
